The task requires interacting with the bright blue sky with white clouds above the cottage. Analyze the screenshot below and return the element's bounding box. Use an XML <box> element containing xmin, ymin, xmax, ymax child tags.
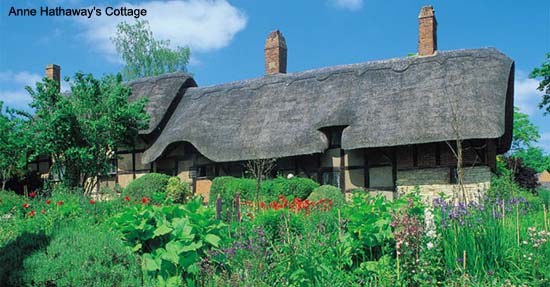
<box><xmin>0</xmin><ymin>0</ymin><xmax>550</xmax><ymax>153</ymax></box>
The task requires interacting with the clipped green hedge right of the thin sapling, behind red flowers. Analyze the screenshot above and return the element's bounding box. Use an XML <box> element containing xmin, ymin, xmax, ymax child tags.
<box><xmin>262</xmin><ymin>177</ymin><xmax>319</xmax><ymax>201</ymax></box>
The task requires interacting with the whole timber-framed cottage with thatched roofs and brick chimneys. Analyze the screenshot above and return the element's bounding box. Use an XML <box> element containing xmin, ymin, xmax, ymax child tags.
<box><xmin>35</xmin><ymin>7</ymin><xmax>514</xmax><ymax>201</ymax></box>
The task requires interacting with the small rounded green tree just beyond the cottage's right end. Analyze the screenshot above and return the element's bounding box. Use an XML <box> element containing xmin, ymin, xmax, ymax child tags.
<box><xmin>512</xmin><ymin>107</ymin><xmax>540</xmax><ymax>152</ymax></box>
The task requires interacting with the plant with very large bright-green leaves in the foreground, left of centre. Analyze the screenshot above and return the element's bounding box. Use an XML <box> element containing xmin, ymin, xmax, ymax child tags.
<box><xmin>112</xmin><ymin>197</ymin><xmax>224</xmax><ymax>286</ymax></box>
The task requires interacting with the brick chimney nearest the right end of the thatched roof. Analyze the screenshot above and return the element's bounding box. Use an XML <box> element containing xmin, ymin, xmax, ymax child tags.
<box><xmin>418</xmin><ymin>6</ymin><xmax>437</xmax><ymax>56</ymax></box>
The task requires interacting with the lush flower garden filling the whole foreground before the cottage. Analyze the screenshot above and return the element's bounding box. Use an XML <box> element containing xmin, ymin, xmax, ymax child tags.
<box><xmin>0</xmin><ymin>168</ymin><xmax>550</xmax><ymax>286</ymax></box>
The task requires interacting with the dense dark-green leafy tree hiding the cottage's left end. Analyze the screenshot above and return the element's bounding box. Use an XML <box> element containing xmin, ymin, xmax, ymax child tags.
<box><xmin>27</xmin><ymin>73</ymin><xmax>148</xmax><ymax>193</ymax></box>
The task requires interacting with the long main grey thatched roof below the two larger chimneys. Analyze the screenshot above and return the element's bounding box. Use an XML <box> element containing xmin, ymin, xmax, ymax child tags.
<box><xmin>143</xmin><ymin>48</ymin><xmax>513</xmax><ymax>163</ymax></box>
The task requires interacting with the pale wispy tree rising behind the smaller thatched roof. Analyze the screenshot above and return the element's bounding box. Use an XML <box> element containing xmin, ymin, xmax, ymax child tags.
<box><xmin>111</xmin><ymin>20</ymin><xmax>190</xmax><ymax>80</ymax></box>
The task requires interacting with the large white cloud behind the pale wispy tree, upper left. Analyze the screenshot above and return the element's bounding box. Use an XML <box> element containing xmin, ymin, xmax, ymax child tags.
<box><xmin>75</xmin><ymin>0</ymin><xmax>247</xmax><ymax>60</ymax></box>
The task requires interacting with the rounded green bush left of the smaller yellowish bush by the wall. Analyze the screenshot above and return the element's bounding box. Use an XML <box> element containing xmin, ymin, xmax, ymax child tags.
<box><xmin>124</xmin><ymin>173</ymin><xmax>170</xmax><ymax>202</ymax></box>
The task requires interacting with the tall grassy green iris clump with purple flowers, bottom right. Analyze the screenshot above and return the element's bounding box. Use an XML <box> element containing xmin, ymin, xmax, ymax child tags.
<box><xmin>435</xmin><ymin>194</ymin><xmax>550</xmax><ymax>286</ymax></box>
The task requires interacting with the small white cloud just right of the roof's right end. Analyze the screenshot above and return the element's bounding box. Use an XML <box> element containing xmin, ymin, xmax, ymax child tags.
<box><xmin>514</xmin><ymin>73</ymin><xmax>542</xmax><ymax>115</ymax></box>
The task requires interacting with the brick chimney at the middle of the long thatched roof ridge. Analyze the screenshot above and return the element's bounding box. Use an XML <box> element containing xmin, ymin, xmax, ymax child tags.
<box><xmin>264</xmin><ymin>30</ymin><xmax>286</xmax><ymax>75</ymax></box>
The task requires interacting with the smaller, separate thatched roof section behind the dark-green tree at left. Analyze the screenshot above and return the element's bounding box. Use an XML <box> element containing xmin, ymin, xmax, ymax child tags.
<box><xmin>128</xmin><ymin>73</ymin><xmax>197</xmax><ymax>138</ymax></box>
